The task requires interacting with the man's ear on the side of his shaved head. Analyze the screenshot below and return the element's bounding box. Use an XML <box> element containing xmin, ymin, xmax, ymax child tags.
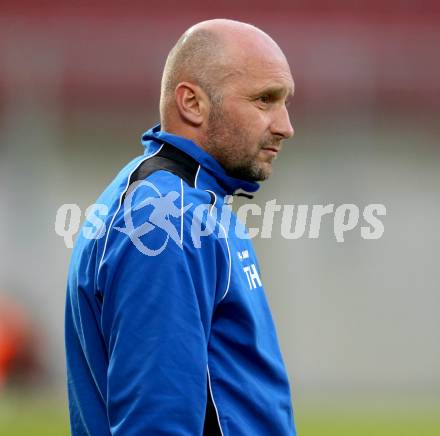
<box><xmin>174</xmin><ymin>82</ymin><xmax>209</xmax><ymax>126</ymax></box>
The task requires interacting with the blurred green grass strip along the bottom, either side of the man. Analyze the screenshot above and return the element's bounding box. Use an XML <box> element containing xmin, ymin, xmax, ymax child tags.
<box><xmin>0</xmin><ymin>394</ymin><xmax>440</xmax><ymax>436</ymax></box>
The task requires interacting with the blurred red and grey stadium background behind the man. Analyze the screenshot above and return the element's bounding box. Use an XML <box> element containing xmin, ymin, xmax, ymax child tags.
<box><xmin>0</xmin><ymin>0</ymin><xmax>440</xmax><ymax>436</ymax></box>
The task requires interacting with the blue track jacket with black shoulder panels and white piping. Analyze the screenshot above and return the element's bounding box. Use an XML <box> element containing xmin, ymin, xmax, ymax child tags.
<box><xmin>65</xmin><ymin>125</ymin><xmax>296</xmax><ymax>436</ymax></box>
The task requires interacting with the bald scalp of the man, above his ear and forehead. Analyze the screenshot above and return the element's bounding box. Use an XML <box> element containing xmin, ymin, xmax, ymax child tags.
<box><xmin>160</xmin><ymin>19</ymin><xmax>284</xmax><ymax>126</ymax></box>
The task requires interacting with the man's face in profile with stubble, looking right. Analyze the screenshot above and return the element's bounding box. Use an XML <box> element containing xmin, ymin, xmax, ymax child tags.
<box><xmin>206</xmin><ymin>52</ymin><xmax>294</xmax><ymax>181</ymax></box>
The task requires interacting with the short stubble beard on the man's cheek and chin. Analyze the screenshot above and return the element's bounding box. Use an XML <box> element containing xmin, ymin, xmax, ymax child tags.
<box><xmin>206</xmin><ymin>105</ymin><xmax>274</xmax><ymax>182</ymax></box>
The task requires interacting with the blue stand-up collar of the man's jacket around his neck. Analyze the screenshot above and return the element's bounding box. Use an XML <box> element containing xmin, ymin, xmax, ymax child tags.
<box><xmin>142</xmin><ymin>124</ymin><xmax>260</xmax><ymax>195</ymax></box>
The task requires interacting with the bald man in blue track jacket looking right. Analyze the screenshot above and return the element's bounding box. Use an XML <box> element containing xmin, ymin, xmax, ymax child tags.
<box><xmin>66</xmin><ymin>20</ymin><xmax>295</xmax><ymax>436</ymax></box>
